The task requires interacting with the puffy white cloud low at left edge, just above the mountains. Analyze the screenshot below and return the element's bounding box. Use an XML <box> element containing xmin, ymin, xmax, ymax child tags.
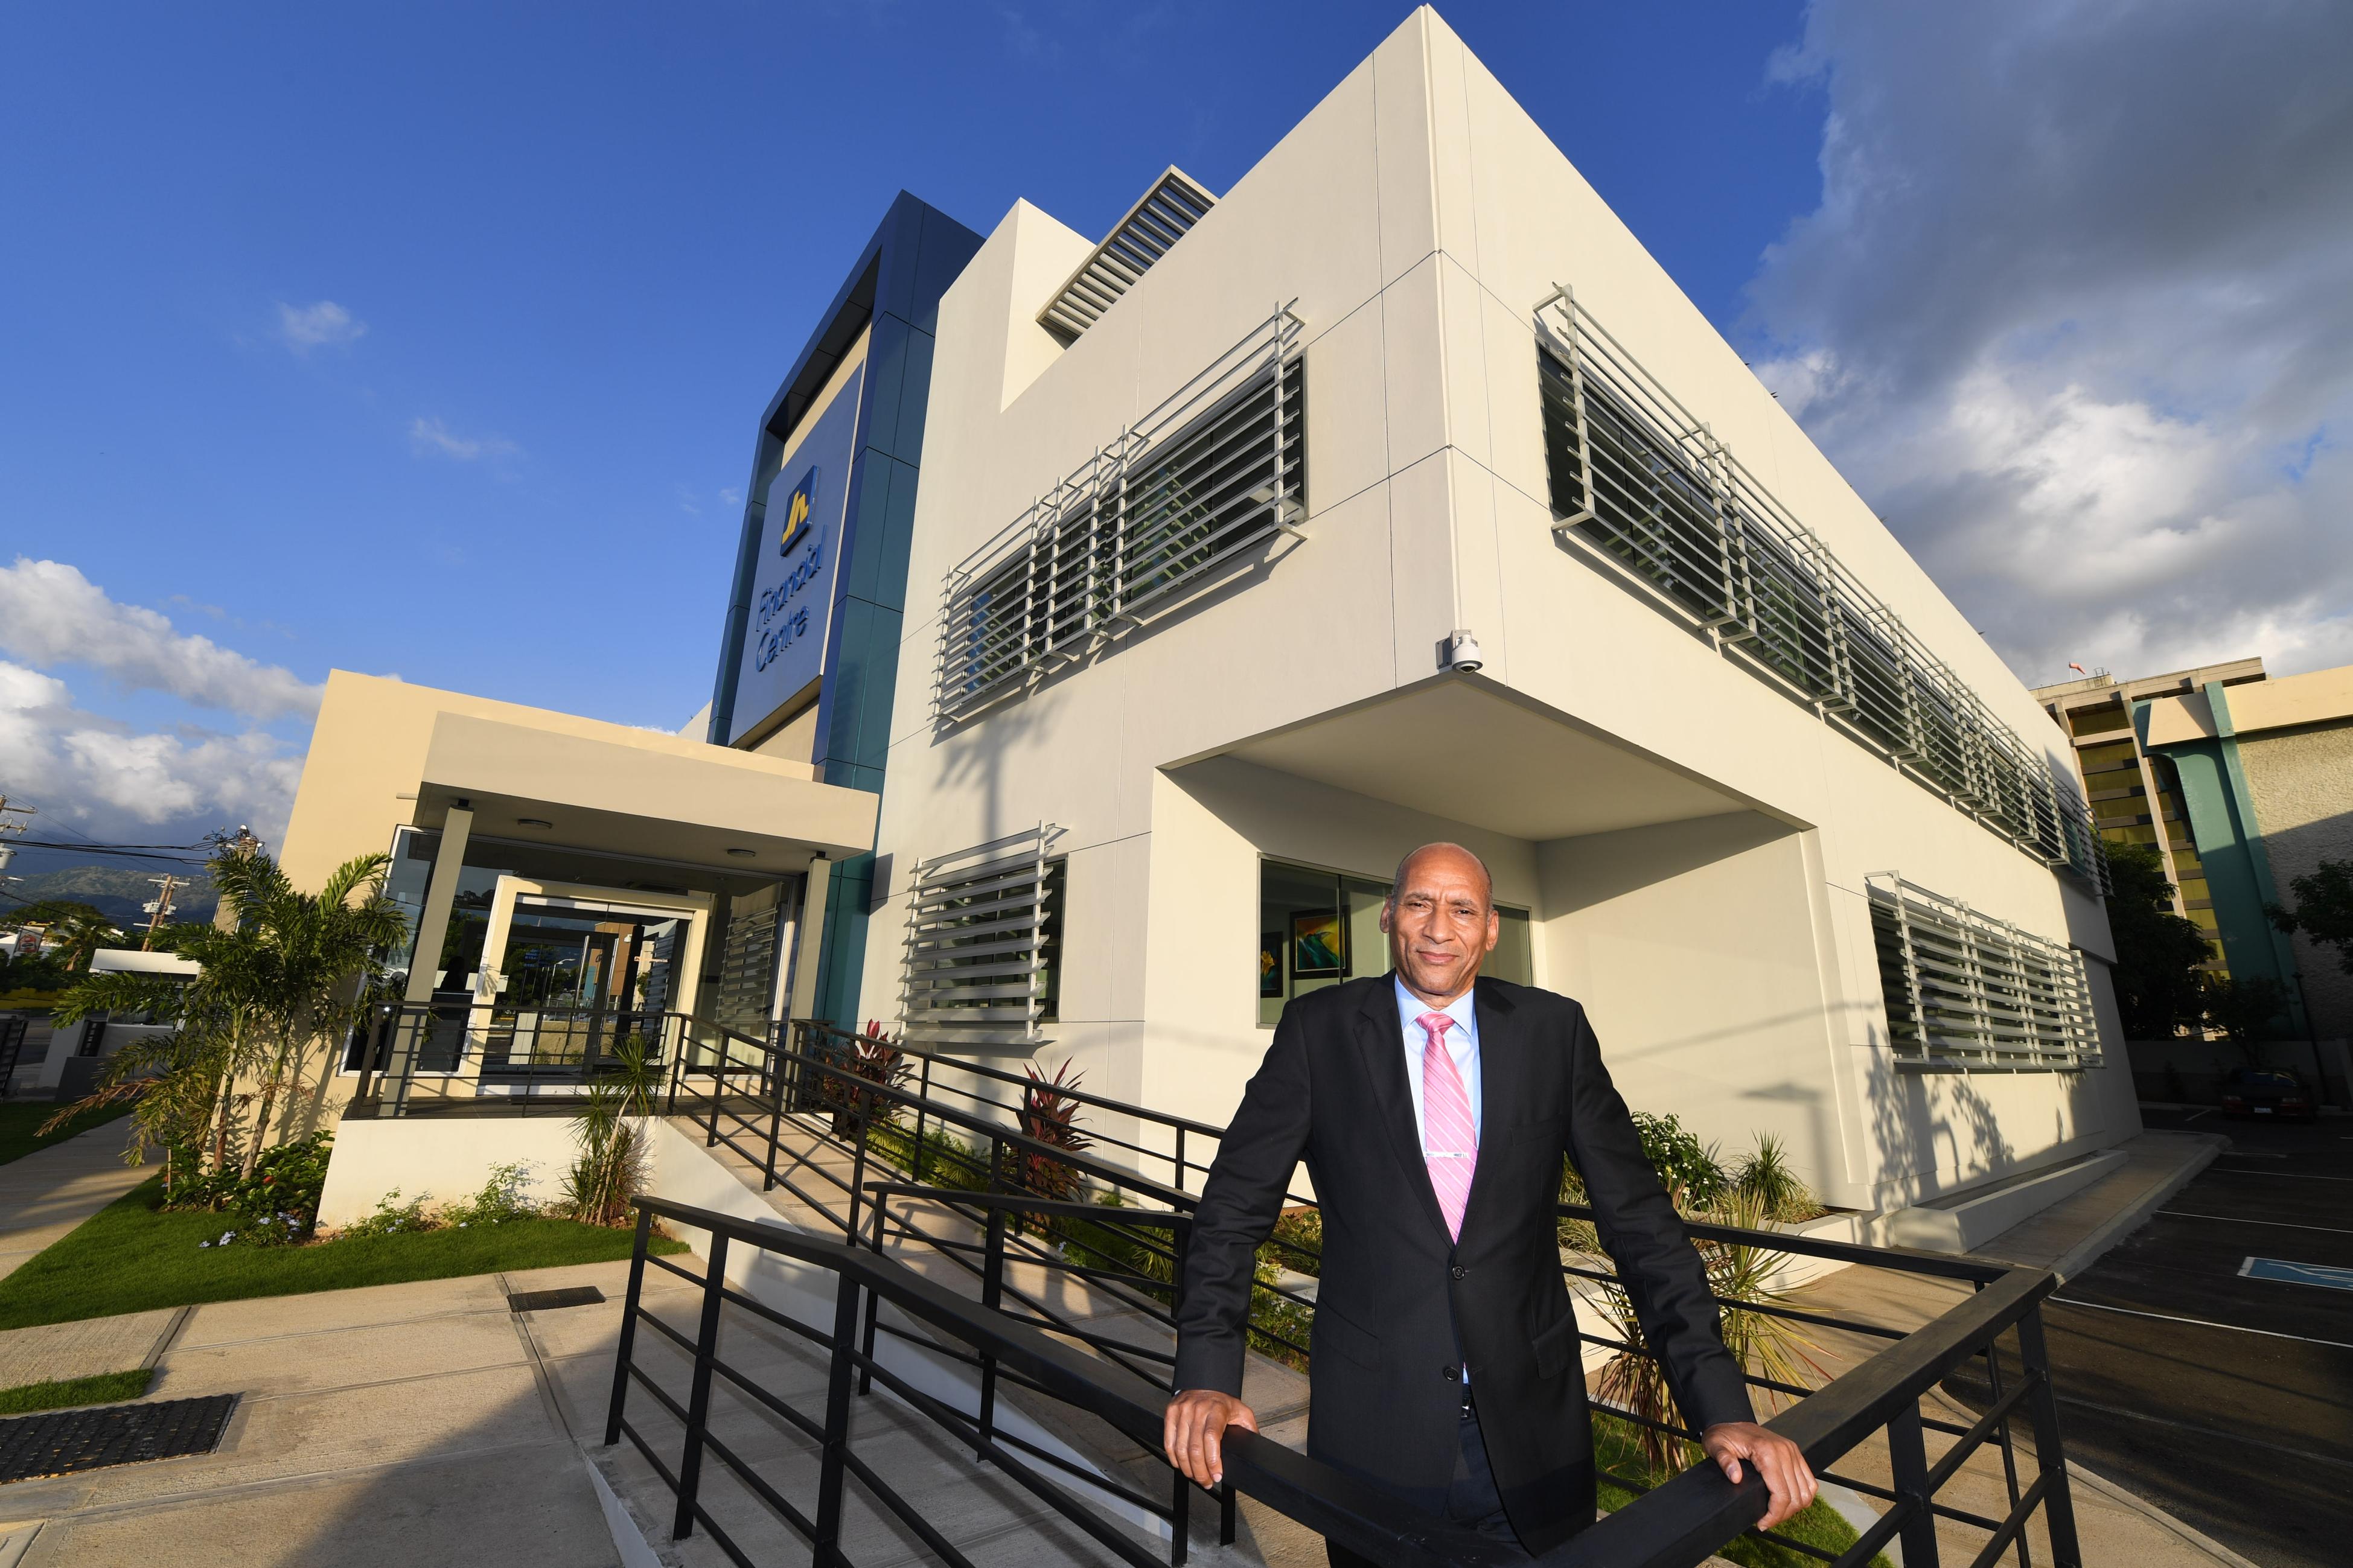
<box><xmin>0</xmin><ymin>659</ymin><xmax>301</xmax><ymax>843</ymax></box>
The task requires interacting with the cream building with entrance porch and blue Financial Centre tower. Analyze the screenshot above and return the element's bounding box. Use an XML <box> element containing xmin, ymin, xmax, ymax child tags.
<box><xmin>287</xmin><ymin>10</ymin><xmax>2139</xmax><ymax>1210</ymax></box>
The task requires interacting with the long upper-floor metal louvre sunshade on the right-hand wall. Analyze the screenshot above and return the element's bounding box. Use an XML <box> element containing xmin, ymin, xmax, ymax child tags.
<box><xmin>1536</xmin><ymin>290</ymin><xmax>2109</xmax><ymax>892</ymax></box>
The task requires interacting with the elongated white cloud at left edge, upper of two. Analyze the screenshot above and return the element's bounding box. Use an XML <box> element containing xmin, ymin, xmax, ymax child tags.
<box><xmin>0</xmin><ymin>556</ymin><xmax>325</xmax><ymax>715</ymax></box>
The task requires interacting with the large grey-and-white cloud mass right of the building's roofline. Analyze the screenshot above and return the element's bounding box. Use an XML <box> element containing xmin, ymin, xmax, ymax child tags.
<box><xmin>1751</xmin><ymin>0</ymin><xmax>2353</xmax><ymax>680</ymax></box>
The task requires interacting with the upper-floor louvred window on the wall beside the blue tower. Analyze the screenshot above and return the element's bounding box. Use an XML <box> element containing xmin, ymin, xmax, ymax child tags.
<box><xmin>936</xmin><ymin>308</ymin><xmax>1306</xmax><ymax>723</ymax></box>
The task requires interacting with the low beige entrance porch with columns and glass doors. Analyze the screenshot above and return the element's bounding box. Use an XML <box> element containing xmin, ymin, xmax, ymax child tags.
<box><xmin>280</xmin><ymin>671</ymin><xmax>875</xmax><ymax>1123</ymax></box>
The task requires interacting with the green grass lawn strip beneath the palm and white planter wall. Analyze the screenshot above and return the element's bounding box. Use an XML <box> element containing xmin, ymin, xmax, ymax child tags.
<box><xmin>0</xmin><ymin>1177</ymin><xmax>687</xmax><ymax>1328</ymax></box>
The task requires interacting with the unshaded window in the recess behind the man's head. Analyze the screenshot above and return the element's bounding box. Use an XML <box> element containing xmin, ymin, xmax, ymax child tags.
<box><xmin>1259</xmin><ymin>859</ymin><xmax>1536</xmax><ymax>1029</ymax></box>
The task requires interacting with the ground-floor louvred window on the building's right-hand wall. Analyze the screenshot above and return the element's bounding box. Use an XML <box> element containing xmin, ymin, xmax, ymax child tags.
<box><xmin>1868</xmin><ymin>871</ymin><xmax>2101</xmax><ymax>1071</ymax></box>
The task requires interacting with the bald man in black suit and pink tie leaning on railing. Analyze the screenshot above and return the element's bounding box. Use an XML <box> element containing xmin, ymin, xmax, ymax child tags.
<box><xmin>1167</xmin><ymin>843</ymin><xmax>1814</xmax><ymax>1568</ymax></box>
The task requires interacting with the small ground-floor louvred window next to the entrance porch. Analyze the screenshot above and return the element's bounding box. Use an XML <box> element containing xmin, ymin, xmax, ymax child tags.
<box><xmin>901</xmin><ymin>824</ymin><xmax>1064</xmax><ymax>1053</ymax></box>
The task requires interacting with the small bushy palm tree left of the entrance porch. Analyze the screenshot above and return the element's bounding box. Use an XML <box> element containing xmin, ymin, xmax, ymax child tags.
<box><xmin>57</xmin><ymin>847</ymin><xmax>407</xmax><ymax>1175</ymax></box>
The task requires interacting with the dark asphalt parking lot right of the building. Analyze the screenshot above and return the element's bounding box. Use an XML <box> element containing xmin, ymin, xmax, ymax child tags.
<box><xmin>2045</xmin><ymin>1109</ymin><xmax>2353</xmax><ymax>1568</ymax></box>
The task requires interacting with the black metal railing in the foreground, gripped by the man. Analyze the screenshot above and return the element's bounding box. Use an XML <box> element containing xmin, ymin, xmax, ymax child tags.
<box><xmin>605</xmin><ymin>1184</ymin><xmax>2080</xmax><ymax>1568</ymax></box>
